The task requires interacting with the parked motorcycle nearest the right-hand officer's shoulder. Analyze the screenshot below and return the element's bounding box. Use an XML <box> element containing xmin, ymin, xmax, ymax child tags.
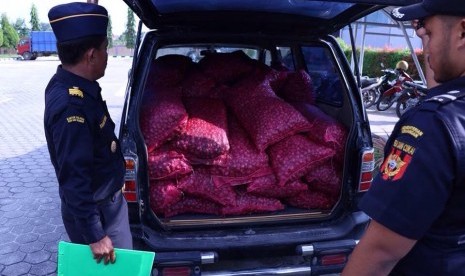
<box><xmin>396</xmin><ymin>81</ymin><xmax>427</xmax><ymax>118</ymax></box>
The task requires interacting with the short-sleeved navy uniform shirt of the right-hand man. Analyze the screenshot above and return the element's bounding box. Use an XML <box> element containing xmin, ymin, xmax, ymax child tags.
<box><xmin>360</xmin><ymin>77</ymin><xmax>465</xmax><ymax>275</ymax></box>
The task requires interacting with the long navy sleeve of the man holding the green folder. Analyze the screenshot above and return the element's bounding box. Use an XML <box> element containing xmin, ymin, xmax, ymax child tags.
<box><xmin>52</xmin><ymin>105</ymin><xmax>105</xmax><ymax>244</ymax></box>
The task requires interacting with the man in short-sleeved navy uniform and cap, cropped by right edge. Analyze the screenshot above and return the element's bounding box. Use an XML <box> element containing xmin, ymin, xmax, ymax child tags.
<box><xmin>343</xmin><ymin>0</ymin><xmax>465</xmax><ymax>276</ymax></box>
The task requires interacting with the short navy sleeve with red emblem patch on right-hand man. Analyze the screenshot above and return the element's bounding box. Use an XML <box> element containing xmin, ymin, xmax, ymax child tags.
<box><xmin>360</xmin><ymin>112</ymin><xmax>454</xmax><ymax>240</ymax></box>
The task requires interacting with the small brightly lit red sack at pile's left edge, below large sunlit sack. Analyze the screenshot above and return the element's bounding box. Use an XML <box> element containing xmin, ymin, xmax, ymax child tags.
<box><xmin>148</xmin><ymin>146</ymin><xmax>192</xmax><ymax>180</ymax></box>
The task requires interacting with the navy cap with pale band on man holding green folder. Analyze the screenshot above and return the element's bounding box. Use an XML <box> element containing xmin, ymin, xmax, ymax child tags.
<box><xmin>48</xmin><ymin>2</ymin><xmax>108</xmax><ymax>42</ymax></box>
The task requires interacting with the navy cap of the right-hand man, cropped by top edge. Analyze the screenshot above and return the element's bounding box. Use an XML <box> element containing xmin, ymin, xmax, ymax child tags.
<box><xmin>391</xmin><ymin>0</ymin><xmax>465</xmax><ymax>21</ymax></box>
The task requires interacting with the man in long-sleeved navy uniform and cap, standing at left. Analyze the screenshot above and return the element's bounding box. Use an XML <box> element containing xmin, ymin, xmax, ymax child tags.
<box><xmin>44</xmin><ymin>2</ymin><xmax>132</xmax><ymax>263</ymax></box>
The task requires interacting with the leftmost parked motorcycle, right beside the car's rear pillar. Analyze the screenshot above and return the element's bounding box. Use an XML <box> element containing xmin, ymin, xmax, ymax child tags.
<box><xmin>360</xmin><ymin>69</ymin><xmax>396</xmax><ymax>108</ymax></box>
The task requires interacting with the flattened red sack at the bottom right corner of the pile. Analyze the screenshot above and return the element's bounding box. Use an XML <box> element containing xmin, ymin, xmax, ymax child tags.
<box><xmin>285</xmin><ymin>190</ymin><xmax>337</xmax><ymax>210</ymax></box>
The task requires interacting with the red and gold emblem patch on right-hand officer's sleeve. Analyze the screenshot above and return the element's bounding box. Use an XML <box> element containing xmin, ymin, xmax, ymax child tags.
<box><xmin>381</xmin><ymin>147</ymin><xmax>412</xmax><ymax>181</ymax></box>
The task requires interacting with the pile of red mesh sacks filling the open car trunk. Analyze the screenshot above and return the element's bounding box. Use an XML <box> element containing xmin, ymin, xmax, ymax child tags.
<box><xmin>140</xmin><ymin>51</ymin><xmax>347</xmax><ymax>217</ymax></box>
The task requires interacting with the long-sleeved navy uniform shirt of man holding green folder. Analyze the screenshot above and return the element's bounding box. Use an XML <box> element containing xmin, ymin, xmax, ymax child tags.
<box><xmin>44</xmin><ymin>66</ymin><xmax>125</xmax><ymax>243</ymax></box>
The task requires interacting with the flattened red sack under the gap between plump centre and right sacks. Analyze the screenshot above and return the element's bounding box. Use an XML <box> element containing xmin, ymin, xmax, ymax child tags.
<box><xmin>247</xmin><ymin>174</ymin><xmax>308</xmax><ymax>199</ymax></box>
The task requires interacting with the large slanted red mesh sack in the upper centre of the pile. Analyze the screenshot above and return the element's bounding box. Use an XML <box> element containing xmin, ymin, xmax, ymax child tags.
<box><xmin>228</xmin><ymin>96</ymin><xmax>311</xmax><ymax>151</ymax></box>
